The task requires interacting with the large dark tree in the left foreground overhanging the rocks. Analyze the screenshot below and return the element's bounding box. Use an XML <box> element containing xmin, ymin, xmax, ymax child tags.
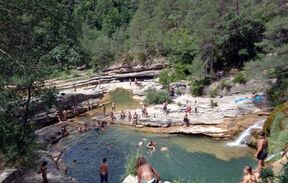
<box><xmin>0</xmin><ymin>0</ymin><xmax>82</xmax><ymax>161</ymax></box>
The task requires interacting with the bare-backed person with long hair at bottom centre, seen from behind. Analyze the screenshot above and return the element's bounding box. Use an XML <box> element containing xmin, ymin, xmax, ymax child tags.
<box><xmin>136</xmin><ymin>157</ymin><xmax>160</xmax><ymax>183</ymax></box>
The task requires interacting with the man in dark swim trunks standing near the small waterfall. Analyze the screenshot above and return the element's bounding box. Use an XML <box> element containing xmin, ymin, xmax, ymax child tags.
<box><xmin>255</xmin><ymin>131</ymin><xmax>268</xmax><ymax>173</ymax></box>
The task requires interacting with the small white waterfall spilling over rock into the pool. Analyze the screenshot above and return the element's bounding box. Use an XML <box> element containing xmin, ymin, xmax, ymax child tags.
<box><xmin>226</xmin><ymin>119</ymin><xmax>265</xmax><ymax>146</ymax></box>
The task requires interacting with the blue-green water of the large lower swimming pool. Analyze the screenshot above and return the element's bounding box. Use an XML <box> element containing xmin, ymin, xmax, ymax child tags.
<box><xmin>64</xmin><ymin>126</ymin><xmax>256</xmax><ymax>183</ymax></box>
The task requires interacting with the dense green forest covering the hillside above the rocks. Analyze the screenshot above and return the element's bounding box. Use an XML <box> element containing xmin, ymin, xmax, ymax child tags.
<box><xmin>0</xmin><ymin>0</ymin><xmax>288</xmax><ymax>167</ymax></box>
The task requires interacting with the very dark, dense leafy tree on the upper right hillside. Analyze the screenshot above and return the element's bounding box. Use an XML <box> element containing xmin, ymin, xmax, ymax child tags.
<box><xmin>218</xmin><ymin>13</ymin><xmax>264</xmax><ymax>68</ymax></box>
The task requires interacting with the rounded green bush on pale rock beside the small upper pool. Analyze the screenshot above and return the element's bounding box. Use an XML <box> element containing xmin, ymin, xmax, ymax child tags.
<box><xmin>144</xmin><ymin>89</ymin><xmax>172</xmax><ymax>104</ymax></box>
